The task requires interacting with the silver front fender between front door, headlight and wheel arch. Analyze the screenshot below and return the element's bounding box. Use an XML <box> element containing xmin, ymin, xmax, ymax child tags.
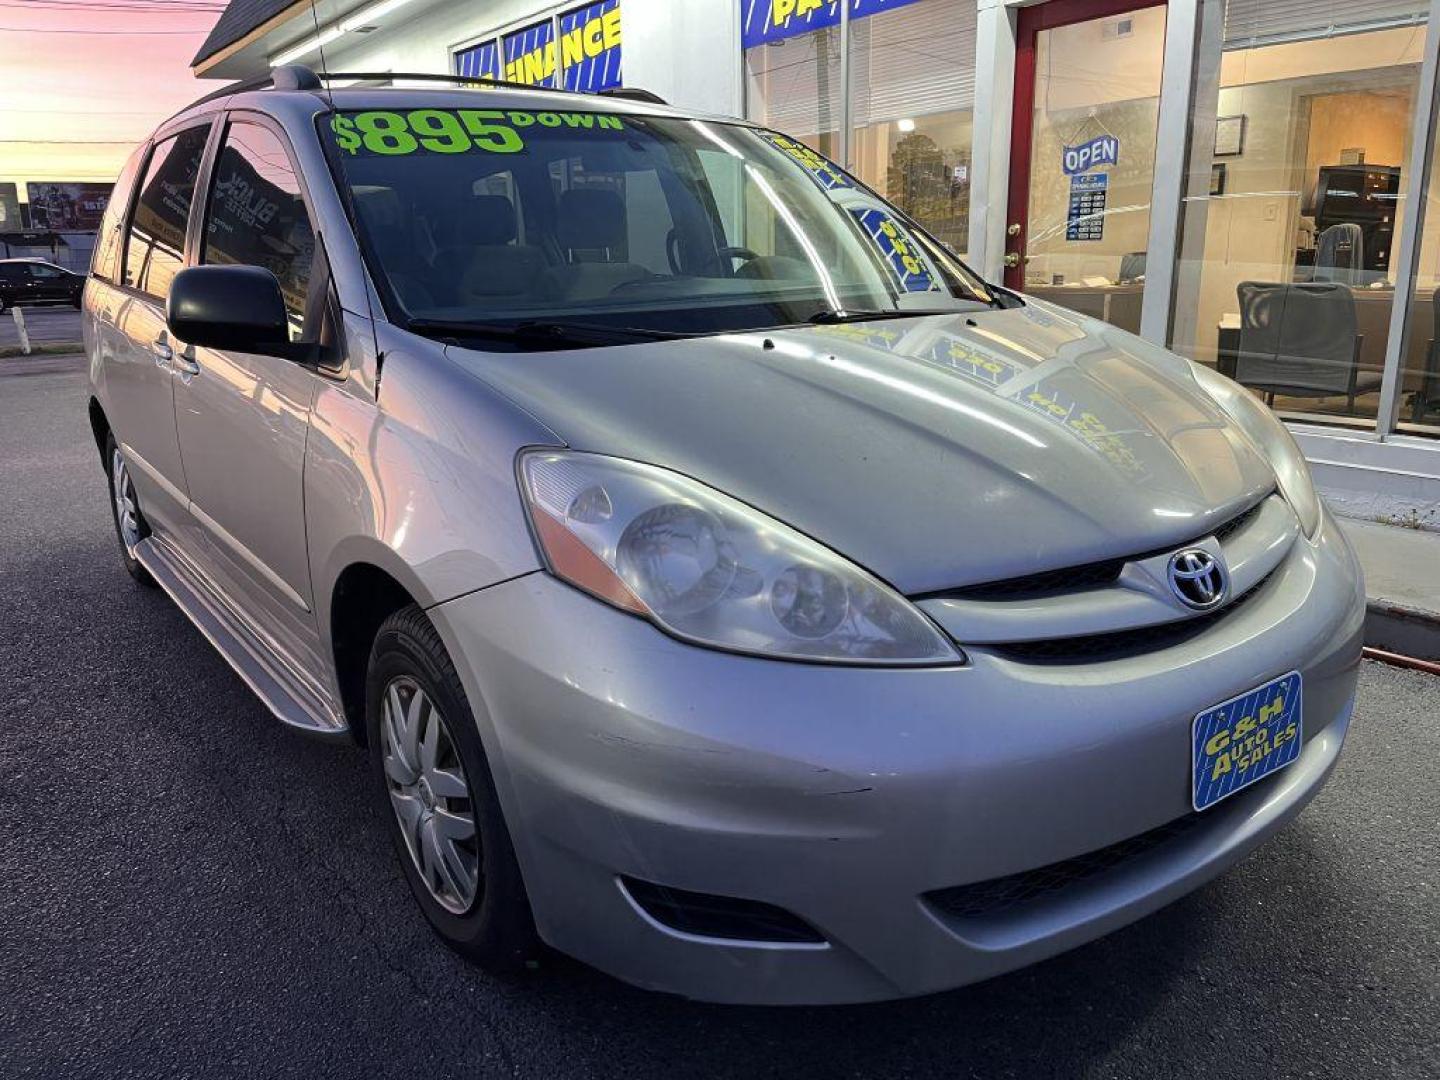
<box><xmin>305</xmin><ymin>327</ymin><xmax>563</xmax><ymax>656</ymax></box>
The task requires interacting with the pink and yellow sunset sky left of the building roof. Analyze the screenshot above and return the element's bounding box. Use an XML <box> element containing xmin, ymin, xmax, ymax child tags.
<box><xmin>0</xmin><ymin>0</ymin><xmax>225</xmax><ymax>200</ymax></box>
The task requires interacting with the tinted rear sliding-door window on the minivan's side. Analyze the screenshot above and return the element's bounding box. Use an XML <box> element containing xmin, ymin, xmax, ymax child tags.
<box><xmin>125</xmin><ymin>127</ymin><xmax>210</xmax><ymax>298</ymax></box>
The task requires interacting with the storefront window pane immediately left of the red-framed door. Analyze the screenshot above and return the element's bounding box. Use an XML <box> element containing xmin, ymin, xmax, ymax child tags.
<box><xmin>850</xmin><ymin>0</ymin><xmax>976</xmax><ymax>253</ymax></box>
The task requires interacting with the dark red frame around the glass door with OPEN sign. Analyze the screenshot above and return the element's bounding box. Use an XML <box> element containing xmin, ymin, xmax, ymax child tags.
<box><xmin>1005</xmin><ymin>0</ymin><xmax>1166</xmax><ymax>289</ymax></box>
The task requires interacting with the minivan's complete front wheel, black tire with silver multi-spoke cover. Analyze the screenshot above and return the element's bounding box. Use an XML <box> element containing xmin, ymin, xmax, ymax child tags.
<box><xmin>366</xmin><ymin>606</ymin><xmax>539</xmax><ymax>973</ymax></box>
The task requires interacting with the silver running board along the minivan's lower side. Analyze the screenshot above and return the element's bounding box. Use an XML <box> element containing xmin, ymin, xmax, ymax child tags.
<box><xmin>135</xmin><ymin>537</ymin><xmax>350</xmax><ymax>740</ymax></box>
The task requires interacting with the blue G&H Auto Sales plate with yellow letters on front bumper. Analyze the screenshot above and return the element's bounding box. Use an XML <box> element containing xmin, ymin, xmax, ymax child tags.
<box><xmin>1191</xmin><ymin>671</ymin><xmax>1302</xmax><ymax>811</ymax></box>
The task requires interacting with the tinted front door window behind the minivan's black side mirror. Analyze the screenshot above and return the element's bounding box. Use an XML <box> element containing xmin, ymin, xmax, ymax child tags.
<box><xmin>200</xmin><ymin>122</ymin><xmax>315</xmax><ymax>340</ymax></box>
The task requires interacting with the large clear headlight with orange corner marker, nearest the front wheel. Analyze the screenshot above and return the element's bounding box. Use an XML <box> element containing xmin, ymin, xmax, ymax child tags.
<box><xmin>520</xmin><ymin>451</ymin><xmax>965</xmax><ymax>664</ymax></box>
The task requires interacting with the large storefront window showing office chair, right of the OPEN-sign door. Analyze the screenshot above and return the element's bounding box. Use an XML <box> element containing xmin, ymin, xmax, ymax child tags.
<box><xmin>1171</xmin><ymin>0</ymin><xmax>1437</xmax><ymax>432</ymax></box>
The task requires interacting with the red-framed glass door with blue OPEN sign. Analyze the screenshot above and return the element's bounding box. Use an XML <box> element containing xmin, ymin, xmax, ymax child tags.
<box><xmin>1005</xmin><ymin>0</ymin><xmax>1165</xmax><ymax>333</ymax></box>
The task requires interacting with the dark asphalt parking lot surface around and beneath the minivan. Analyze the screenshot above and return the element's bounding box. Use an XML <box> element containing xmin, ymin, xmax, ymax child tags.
<box><xmin>8</xmin><ymin>357</ymin><xmax>1440</xmax><ymax>1080</ymax></box>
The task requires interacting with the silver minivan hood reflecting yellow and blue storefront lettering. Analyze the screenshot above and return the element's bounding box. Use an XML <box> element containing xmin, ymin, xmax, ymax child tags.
<box><xmin>448</xmin><ymin>301</ymin><xmax>1274</xmax><ymax>595</ymax></box>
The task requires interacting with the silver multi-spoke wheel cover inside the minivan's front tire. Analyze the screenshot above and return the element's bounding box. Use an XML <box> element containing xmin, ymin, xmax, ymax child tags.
<box><xmin>380</xmin><ymin>675</ymin><xmax>480</xmax><ymax>914</ymax></box>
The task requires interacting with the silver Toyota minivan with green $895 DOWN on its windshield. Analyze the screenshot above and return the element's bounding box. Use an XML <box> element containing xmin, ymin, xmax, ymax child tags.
<box><xmin>84</xmin><ymin>68</ymin><xmax>1364</xmax><ymax>1002</ymax></box>
